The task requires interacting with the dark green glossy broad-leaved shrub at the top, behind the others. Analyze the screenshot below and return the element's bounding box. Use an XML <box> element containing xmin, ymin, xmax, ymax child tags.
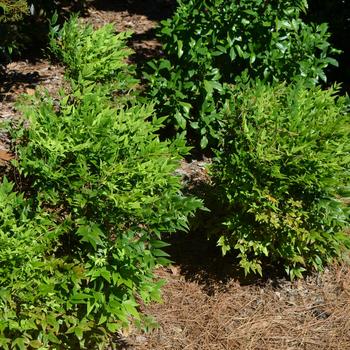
<box><xmin>146</xmin><ymin>0</ymin><xmax>337</xmax><ymax>148</ymax></box>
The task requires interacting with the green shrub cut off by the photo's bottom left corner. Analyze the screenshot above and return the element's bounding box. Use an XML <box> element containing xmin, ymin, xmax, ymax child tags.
<box><xmin>0</xmin><ymin>179</ymin><xmax>83</xmax><ymax>349</ymax></box>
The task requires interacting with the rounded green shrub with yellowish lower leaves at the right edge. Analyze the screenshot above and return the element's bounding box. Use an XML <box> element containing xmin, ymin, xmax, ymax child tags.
<box><xmin>212</xmin><ymin>83</ymin><xmax>350</xmax><ymax>278</ymax></box>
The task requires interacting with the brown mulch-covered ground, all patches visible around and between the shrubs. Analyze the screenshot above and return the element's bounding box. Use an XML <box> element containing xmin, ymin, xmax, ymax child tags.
<box><xmin>0</xmin><ymin>0</ymin><xmax>350</xmax><ymax>350</ymax></box>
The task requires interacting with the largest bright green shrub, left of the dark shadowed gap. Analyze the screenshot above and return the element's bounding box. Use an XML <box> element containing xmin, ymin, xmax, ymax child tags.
<box><xmin>8</xmin><ymin>88</ymin><xmax>200</xmax><ymax>349</ymax></box>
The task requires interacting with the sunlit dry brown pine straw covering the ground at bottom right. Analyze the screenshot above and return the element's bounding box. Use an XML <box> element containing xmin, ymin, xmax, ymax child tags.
<box><xmin>122</xmin><ymin>265</ymin><xmax>350</xmax><ymax>350</ymax></box>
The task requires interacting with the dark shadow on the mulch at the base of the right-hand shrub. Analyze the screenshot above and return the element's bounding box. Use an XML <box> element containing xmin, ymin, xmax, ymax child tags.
<box><xmin>165</xmin><ymin>183</ymin><xmax>286</xmax><ymax>295</ymax></box>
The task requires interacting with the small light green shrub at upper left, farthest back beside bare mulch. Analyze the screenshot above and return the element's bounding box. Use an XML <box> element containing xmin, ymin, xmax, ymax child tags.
<box><xmin>50</xmin><ymin>16</ymin><xmax>136</xmax><ymax>92</ymax></box>
